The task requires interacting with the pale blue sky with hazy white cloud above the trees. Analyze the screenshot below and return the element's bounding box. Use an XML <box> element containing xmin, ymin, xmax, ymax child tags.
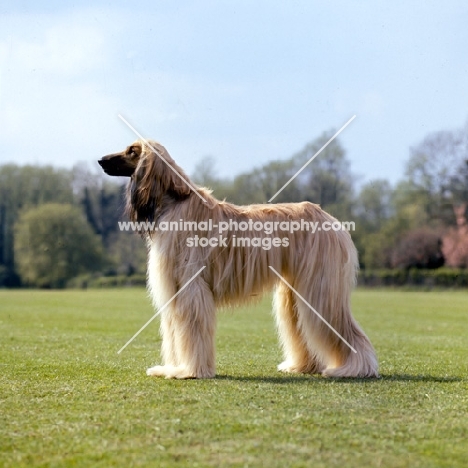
<box><xmin>0</xmin><ymin>0</ymin><xmax>468</xmax><ymax>183</ymax></box>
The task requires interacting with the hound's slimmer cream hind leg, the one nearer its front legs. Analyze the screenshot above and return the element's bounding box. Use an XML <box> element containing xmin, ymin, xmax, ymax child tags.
<box><xmin>273</xmin><ymin>283</ymin><xmax>323</xmax><ymax>374</ymax></box>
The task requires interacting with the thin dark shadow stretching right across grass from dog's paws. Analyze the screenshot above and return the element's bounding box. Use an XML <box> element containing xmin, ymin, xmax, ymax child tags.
<box><xmin>216</xmin><ymin>374</ymin><xmax>466</xmax><ymax>385</ymax></box>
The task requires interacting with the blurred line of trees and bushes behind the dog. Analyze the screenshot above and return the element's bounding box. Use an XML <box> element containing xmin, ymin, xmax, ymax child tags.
<box><xmin>0</xmin><ymin>124</ymin><xmax>468</xmax><ymax>287</ymax></box>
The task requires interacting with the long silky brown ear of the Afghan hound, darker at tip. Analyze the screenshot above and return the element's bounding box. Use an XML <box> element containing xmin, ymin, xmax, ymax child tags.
<box><xmin>127</xmin><ymin>142</ymin><xmax>191</xmax><ymax>221</ymax></box>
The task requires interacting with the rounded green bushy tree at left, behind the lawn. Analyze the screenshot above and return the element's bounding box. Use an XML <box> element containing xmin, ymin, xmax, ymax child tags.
<box><xmin>15</xmin><ymin>203</ymin><xmax>104</xmax><ymax>288</ymax></box>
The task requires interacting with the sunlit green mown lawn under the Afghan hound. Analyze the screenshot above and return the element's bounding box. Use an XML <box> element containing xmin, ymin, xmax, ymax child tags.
<box><xmin>0</xmin><ymin>289</ymin><xmax>468</xmax><ymax>468</ymax></box>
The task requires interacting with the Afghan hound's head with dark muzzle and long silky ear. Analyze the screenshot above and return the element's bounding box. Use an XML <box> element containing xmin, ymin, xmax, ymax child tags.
<box><xmin>98</xmin><ymin>141</ymin><xmax>193</xmax><ymax>221</ymax></box>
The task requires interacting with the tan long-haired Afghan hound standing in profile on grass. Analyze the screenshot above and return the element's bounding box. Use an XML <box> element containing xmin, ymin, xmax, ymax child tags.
<box><xmin>99</xmin><ymin>141</ymin><xmax>378</xmax><ymax>379</ymax></box>
